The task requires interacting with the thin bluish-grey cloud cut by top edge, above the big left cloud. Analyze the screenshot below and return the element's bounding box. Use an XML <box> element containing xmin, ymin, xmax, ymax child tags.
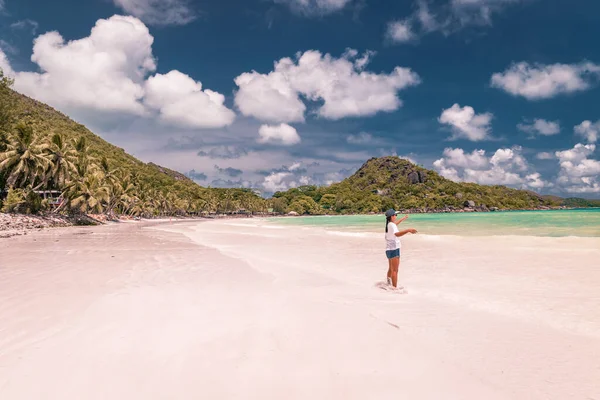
<box><xmin>114</xmin><ymin>0</ymin><xmax>196</xmax><ymax>25</ymax></box>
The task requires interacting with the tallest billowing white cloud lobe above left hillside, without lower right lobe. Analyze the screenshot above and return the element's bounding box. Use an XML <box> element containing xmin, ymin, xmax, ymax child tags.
<box><xmin>10</xmin><ymin>16</ymin><xmax>156</xmax><ymax>115</ymax></box>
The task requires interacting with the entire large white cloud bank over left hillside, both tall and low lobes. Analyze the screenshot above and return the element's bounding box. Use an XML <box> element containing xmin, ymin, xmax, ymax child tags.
<box><xmin>0</xmin><ymin>16</ymin><xmax>235</xmax><ymax>128</ymax></box>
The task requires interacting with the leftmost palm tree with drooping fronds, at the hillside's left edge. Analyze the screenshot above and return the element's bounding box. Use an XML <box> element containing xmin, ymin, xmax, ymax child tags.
<box><xmin>0</xmin><ymin>124</ymin><xmax>49</xmax><ymax>187</ymax></box>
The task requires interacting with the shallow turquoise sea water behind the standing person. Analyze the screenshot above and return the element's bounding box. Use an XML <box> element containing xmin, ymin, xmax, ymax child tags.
<box><xmin>269</xmin><ymin>208</ymin><xmax>600</xmax><ymax>237</ymax></box>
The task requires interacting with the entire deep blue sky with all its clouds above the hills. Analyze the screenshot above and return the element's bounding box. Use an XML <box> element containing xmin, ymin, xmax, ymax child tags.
<box><xmin>0</xmin><ymin>0</ymin><xmax>600</xmax><ymax>198</ymax></box>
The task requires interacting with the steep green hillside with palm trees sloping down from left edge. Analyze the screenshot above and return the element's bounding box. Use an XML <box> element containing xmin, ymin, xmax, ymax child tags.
<box><xmin>0</xmin><ymin>70</ymin><xmax>266</xmax><ymax>216</ymax></box>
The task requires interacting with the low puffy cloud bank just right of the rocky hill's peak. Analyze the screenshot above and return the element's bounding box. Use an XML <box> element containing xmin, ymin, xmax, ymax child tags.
<box><xmin>433</xmin><ymin>146</ymin><xmax>551</xmax><ymax>189</ymax></box>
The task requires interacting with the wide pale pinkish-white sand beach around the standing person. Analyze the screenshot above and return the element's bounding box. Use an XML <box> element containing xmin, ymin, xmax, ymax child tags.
<box><xmin>0</xmin><ymin>219</ymin><xmax>600</xmax><ymax>400</ymax></box>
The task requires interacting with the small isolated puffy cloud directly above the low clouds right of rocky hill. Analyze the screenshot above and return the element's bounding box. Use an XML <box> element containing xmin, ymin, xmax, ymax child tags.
<box><xmin>438</xmin><ymin>104</ymin><xmax>493</xmax><ymax>142</ymax></box>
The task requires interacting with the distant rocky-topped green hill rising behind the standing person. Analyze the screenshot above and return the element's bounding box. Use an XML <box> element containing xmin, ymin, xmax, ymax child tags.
<box><xmin>273</xmin><ymin>157</ymin><xmax>560</xmax><ymax>214</ymax></box>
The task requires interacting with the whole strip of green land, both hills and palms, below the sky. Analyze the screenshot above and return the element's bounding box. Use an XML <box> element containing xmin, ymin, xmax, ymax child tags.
<box><xmin>0</xmin><ymin>70</ymin><xmax>600</xmax><ymax>230</ymax></box>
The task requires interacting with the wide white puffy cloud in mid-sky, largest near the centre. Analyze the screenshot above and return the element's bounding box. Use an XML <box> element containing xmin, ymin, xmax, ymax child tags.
<box><xmin>235</xmin><ymin>49</ymin><xmax>420</xmax><ymax>122</ymax></box>
